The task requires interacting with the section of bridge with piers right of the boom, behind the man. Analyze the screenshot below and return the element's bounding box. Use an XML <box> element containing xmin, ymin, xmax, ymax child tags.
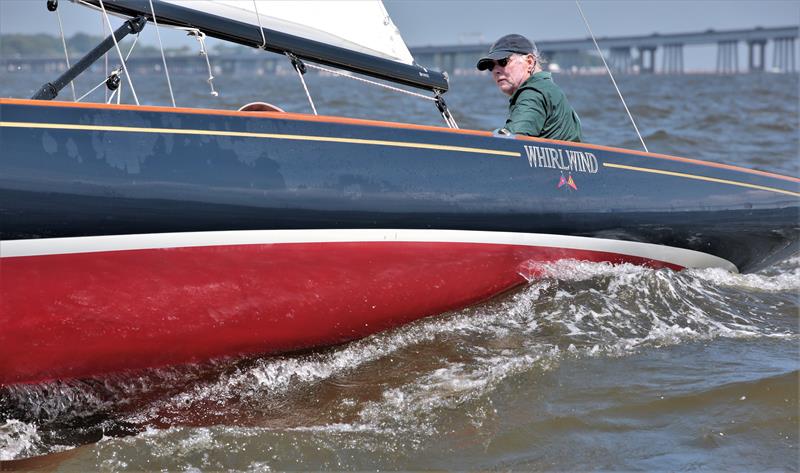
<box><xmin>411</xmin><ymin>26</ymin><xmax>800</xmax><ymax>74</ymax></box>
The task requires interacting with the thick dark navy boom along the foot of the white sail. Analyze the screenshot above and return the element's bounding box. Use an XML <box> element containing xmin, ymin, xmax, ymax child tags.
<box><xmin>73</xmin><ymin>0</ymin><xmax>448</xmax><ymax>93</ymax></box>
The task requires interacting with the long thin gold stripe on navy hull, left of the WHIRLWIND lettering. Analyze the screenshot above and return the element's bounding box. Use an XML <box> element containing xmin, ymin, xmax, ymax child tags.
<box><xmin>0</xmin><ymin>122</ymin><xmax>521</xmax><ymax>158</ymax></box>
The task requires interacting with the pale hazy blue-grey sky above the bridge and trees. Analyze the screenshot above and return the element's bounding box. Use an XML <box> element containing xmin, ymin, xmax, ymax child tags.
<box><xmin>0</xmin><ymin>0</ymin><xmax>800</xmax><ymax>46</ymax></box>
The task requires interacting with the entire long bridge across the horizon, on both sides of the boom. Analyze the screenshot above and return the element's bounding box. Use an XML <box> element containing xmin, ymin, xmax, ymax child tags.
<box><xmin>0</xmin><ymin>26</ymin><xmax>800</xmax><ymax>75</ymax></box>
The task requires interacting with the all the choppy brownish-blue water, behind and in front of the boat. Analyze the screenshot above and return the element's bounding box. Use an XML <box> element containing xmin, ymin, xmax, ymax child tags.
<box><xmin>0</xmin><ymin>64</ymin><xmax>800</xmax><ymax>471</ymax></box>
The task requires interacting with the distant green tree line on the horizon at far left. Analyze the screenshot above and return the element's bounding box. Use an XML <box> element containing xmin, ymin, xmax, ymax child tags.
<box><xmin>0</xmin><ymin>32</ymin><xmax>197</xmax><ymax>58</ymax></box>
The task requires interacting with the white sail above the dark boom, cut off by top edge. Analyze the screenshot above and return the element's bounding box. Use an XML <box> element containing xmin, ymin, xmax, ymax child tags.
<box><xmin>162</xmin><ymin>0</ymin><xmax>414</xmax><ymax>64</ymax></box>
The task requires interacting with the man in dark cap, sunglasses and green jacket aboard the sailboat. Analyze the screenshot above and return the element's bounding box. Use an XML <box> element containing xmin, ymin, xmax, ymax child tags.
<box><xmin>477</xmin><ymin>34</ymin><xmax>581</xmax><ymax>141</ymax></box>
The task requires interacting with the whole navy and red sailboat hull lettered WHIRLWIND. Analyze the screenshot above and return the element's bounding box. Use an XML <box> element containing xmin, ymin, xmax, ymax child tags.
<box><xmin>0</xmin><ymin>99</ymin><xmax>800</xmax><ymax>384</ymax></box>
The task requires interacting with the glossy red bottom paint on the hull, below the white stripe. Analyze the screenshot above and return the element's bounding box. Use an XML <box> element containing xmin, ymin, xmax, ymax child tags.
<box><xmin>0</xmin><ymin>242</ymin><xmax>678</xmax><ymax>384</ymax></box>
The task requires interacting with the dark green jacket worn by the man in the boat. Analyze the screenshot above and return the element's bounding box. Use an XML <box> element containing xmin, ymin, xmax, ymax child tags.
<box><xmin>505</xmin><ymin>72</ymin><xmax>581</xmax><ymax>141</ymax></box>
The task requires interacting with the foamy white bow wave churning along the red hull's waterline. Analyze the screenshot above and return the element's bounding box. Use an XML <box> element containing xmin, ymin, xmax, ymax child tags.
<box><xmin>0</xmin><ymin>257</ymin><xmax>800</xmax><ymax>459</ymax></box>
